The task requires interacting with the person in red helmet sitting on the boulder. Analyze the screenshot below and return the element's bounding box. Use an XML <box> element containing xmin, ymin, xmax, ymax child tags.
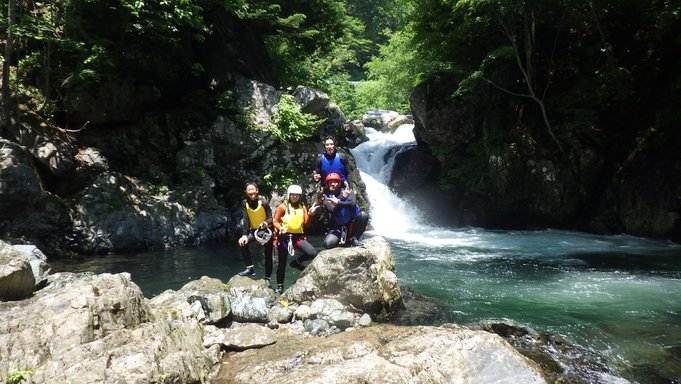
<box><xmin>322</xmin><ymin>173</ymin><xmax>369</xmax><ymax>249</ymax></box>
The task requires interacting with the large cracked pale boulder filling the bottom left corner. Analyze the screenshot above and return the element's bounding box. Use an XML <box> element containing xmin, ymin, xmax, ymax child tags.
<box><xmin>0</xmin><ymin>273</ymin><xmax>220</xmax><ymax>383</ymax></box>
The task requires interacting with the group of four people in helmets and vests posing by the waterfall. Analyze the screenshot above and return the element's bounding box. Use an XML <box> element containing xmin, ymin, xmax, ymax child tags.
<box><xmin>238</xmin><ymin>136</ymin><xmax>369</xmax><ymax>293</ymax></box>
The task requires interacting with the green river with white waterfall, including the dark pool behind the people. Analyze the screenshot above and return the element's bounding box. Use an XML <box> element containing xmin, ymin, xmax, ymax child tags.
<box><xmin>51</xmin><ymin>127</ymin><xmax>681</xmax><ymax>384</ymax></box>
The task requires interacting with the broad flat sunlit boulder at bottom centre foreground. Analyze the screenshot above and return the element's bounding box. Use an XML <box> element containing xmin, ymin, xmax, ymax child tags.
<box><xmin>218</xmin><ymin>324</ymin><xmax>546</xmax><ymax>384</ymax></box>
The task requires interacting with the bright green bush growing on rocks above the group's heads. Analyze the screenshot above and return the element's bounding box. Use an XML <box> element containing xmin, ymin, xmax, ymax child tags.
<box><xmin>267</xmin><ymin>94</ymin><xmax>323</xmax><ymax>142</ymax></box>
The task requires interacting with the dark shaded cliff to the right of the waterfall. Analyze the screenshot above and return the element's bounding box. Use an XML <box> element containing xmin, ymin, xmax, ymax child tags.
<box><xmin>404</xmin><ymin>73</ymin><xmax>681</xmax><ymax>242</ymax></box>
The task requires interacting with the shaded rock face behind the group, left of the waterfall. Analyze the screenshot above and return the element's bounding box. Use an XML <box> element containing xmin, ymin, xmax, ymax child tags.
<box><xmin>0</xmin><ymin>77</ymin><xmax>366</xmax><ymax>257</ymax></box>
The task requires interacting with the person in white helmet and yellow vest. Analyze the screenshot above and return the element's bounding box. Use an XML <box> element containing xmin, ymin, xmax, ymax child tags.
<box><xmin>273</xmin><ymin>185</ymin><xmax>319</xmax><ymax>293</ymax></box>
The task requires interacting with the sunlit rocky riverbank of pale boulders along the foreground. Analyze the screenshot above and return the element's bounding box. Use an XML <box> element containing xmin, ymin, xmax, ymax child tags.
<box><xmin>0</xmin><ymin>237</ymin><xmax>568</xmax><ymax>383</ymax></box>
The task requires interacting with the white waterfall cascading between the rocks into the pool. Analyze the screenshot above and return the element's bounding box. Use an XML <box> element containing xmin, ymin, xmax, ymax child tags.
<box><xmin>351</xmin><ymin>124</ymin><xmax>422</xmax><ymax>238</ymax></box>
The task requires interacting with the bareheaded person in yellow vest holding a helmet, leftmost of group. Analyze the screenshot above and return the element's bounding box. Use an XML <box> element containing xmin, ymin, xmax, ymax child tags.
<box><xmin>239</xmin><ymin>182</ymin><xmax>274</xmax><ymax>286</ymax></box>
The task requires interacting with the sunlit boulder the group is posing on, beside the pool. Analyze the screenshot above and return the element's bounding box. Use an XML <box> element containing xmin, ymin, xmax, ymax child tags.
<box><xmin>283</xmin><ymin>237</ymin><xmax>403</xmax><ymax>319</ymax></box>
